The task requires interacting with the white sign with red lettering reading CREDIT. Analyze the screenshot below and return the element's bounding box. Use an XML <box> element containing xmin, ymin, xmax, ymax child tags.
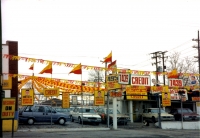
<box><xmin>131</xmin><ymin>74</ymin><xmax>151</xmax><ymax>86</ymax></box>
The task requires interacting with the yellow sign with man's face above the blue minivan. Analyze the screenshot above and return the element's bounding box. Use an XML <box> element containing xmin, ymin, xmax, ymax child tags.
<box><xmin>21</xmin><ymin>89</ymin><xmax>34</xmax><ymax>105</ymax></box>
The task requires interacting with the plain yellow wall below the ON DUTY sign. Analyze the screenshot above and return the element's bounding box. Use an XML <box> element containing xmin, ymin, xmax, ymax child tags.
<box><xmin>2</xmin><ymin>120</ymin><xmax>18</xmax><ymax>132</ymax></box>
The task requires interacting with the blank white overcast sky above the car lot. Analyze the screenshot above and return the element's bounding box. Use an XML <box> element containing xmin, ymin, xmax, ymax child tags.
<box><xmin>1</xmin><ymin>0</ymin><xmax>200</xmax><ymax>80</ymax></box>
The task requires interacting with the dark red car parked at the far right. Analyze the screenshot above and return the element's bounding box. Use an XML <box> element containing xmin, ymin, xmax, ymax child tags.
<box><xmin>170</xmin><ymin>108</ymin><xmax>200</xmax><ymax>121</ymax></box>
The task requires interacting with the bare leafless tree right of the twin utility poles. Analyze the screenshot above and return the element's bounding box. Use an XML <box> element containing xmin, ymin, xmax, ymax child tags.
<box><xmin>166</xmin><ymin>52</ymin><xmax>199</xmax><ymax>85</ymax></box>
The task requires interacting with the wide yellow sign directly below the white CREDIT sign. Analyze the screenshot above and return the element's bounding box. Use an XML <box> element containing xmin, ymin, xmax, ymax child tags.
<box><xmin>126</xmin><ymin>85</ymin><xmax>148</xmax><ymax>100</ymax></box>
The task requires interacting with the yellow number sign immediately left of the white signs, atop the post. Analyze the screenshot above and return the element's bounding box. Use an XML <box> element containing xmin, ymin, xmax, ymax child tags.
<box><xmin>106</xmin><ymin>74</ymin><xmax>121</xmax><ymax>90</ymax></box>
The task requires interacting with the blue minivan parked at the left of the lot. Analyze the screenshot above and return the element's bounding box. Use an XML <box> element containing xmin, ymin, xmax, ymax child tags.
<box><xmin>19</xmin><ymin>105</ymin><xmax>70</xmax><ymax>125</ymax></box>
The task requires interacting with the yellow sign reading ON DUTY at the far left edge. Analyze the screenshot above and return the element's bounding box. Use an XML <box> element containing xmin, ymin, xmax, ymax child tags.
<box><xmin>1</xmin><ymin>98</ymin><xmax>16</xmax><ymax>119</ymax></box>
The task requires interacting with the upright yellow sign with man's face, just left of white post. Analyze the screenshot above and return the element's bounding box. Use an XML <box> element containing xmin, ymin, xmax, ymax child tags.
<box><xmin>94</xmin><ymin>91</ymin><xmax>105</xmax><ymax>105</ymax></box>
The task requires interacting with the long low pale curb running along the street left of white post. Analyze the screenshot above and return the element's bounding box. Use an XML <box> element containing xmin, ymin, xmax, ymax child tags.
<box><xmin>17</xmin><ymin>128</ymin><xmax>110</xmax><ymax>132</ymax></box>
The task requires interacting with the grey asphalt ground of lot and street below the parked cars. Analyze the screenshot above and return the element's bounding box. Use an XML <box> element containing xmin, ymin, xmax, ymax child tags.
<box><xmin>3</xmin><ymin>122</ymin><xmax>200</xmax><ymax>138</ymax></box>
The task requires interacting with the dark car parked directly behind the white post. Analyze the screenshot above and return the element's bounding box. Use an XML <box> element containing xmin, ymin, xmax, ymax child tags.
<box><xmin>97</xmin><ymin>108</ymin><xmax>130</xmax><ymax>125</ymax></box>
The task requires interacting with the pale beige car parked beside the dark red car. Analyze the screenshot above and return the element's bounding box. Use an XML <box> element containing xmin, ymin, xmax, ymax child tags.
<box><xmin>142</xmin><ymin>108</ymin><xmax>174</xmax><ymax>123</ymax></box>
